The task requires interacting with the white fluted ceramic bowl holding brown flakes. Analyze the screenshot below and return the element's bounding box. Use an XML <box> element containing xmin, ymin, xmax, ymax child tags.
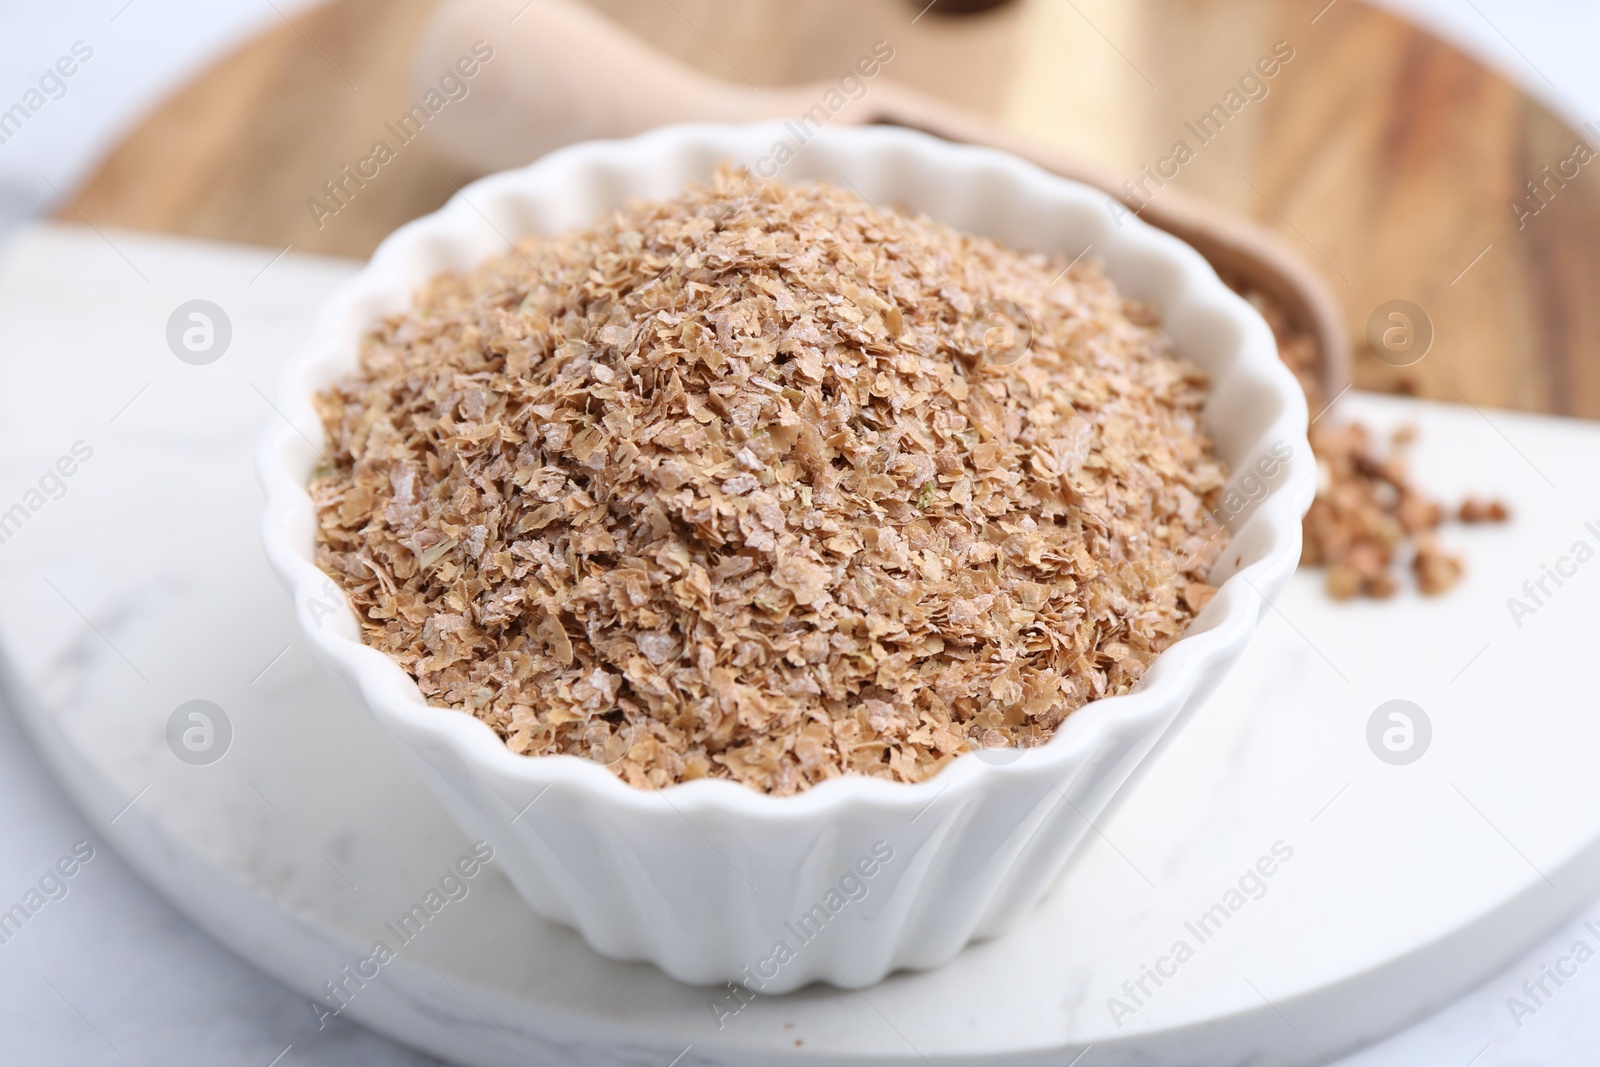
<box><xmin>259</xmin><ymin>125</ymin><xmax>1315</xmax><ymax>1003</ymax></box>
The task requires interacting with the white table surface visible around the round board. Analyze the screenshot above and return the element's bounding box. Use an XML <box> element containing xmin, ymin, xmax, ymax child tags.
<box><xmin>0</xmin><ymin>0</ymin><xmax>1600</xmax><ymax>1067</ymax></box>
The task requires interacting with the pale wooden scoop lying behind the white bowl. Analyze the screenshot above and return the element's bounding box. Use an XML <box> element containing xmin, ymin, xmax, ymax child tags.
<box><xmin>413</xmin><ymin>0</ymin><xmax>1349</xmax><ymax>398</ymax></box>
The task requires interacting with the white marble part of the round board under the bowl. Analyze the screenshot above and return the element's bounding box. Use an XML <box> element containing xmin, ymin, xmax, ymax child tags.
<box><xmin>0</xmin><ymin>226</ymin><xmax>1600</xmax><ymax>1067</ymax></box>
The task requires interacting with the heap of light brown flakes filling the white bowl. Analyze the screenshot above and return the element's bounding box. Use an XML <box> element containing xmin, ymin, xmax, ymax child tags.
<box><xmin>312</xmin><ymin>170</ymin><xmax>1226</xmax><ymax>793</ymax></box>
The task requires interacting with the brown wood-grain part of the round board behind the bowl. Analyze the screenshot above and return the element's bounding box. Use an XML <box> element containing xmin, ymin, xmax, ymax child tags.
<box><xmin>62</xmin><ymin>0</ymin><xmax>1600</xmax><ymax>418</ymax></box>
